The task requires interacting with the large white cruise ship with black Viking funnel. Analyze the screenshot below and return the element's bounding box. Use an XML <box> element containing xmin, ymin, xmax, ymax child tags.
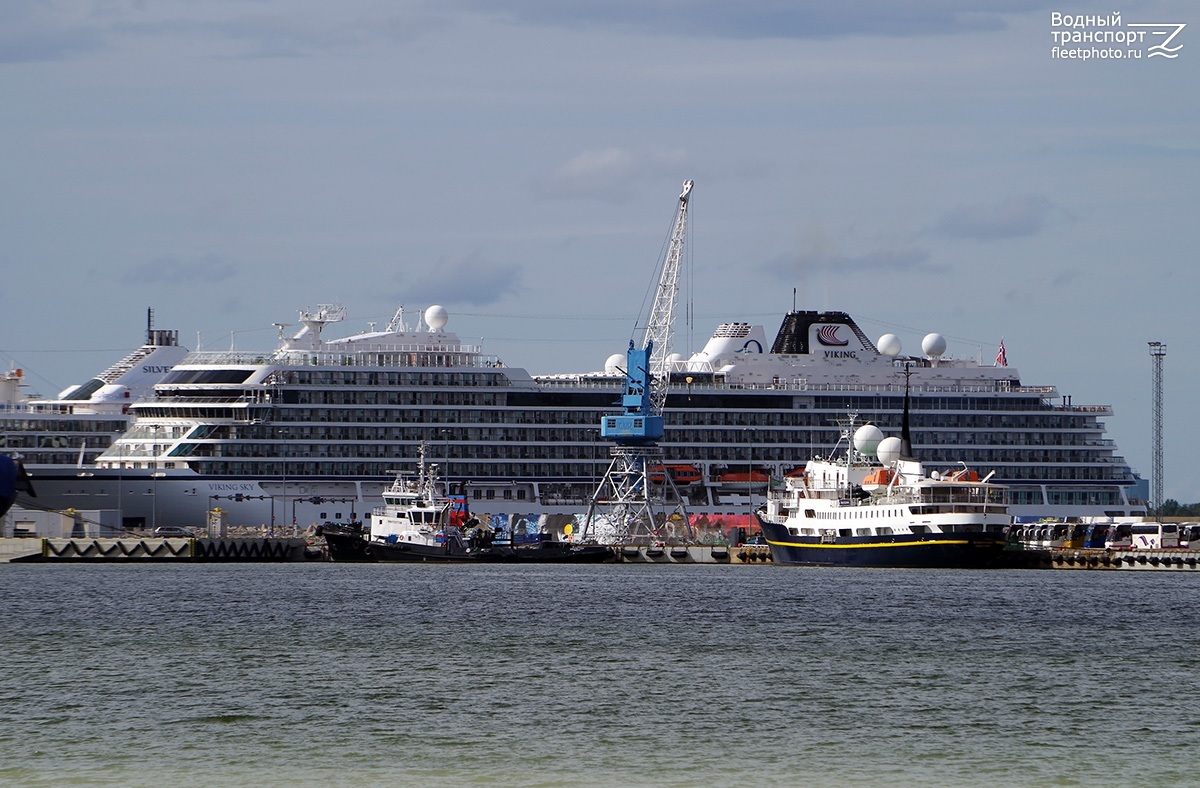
<box><xmin>18</xmin><ymin>298</ymin><xmax>1146</xmax><ymax>533</ymax></box>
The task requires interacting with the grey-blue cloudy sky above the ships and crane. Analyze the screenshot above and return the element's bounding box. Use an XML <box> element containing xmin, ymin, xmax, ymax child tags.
<box><xmin>0</xmin><ymin>0</ymin><xmax>1200</xmax><ymax>503</ymax></box>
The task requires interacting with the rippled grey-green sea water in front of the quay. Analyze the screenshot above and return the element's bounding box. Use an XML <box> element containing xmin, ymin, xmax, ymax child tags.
<box><xmin>0</xmin><ymin>561</ymin><xmax>1200</xmax><ymax>786</ymax></box>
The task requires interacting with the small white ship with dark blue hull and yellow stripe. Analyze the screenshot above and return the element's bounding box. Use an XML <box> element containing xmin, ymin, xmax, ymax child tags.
<box><xmin>755</xmin><ymin>371</ymin><xmax>1012</xmax><ymax>569</ymax></box>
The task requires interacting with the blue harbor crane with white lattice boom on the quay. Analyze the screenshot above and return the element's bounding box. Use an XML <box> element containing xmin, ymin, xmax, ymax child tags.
<box><xmin>582</xmin><ymin>180</ymin><xmax>692</xmax><ymax>543</ymax></box>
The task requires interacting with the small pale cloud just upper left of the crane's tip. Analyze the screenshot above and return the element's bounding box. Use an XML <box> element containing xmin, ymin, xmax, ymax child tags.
<box><xmin>533</xmin><ymin>148</ymin><xmax>686</xmax><ymax>203</ymax></box>
